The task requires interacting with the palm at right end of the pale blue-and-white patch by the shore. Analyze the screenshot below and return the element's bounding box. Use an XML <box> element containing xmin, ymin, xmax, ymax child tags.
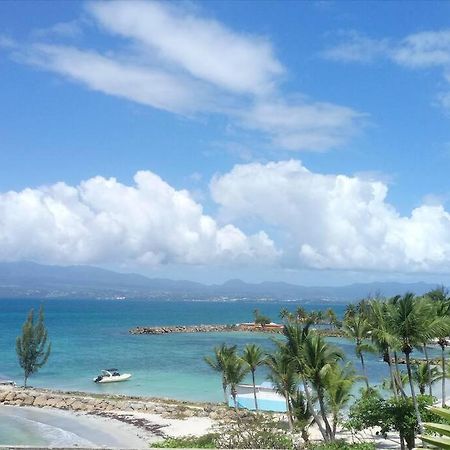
<box><xmin>265</xmin><ymin>350</ymin><xmax>298</xmax><ymax>431</ymax></box>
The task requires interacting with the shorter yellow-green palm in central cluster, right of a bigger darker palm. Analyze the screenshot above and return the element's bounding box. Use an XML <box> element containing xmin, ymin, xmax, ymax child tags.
<box><xmin>326</xmin><ymin>364</ymin><xmax>358</xmax><ymax>439</ymax></box>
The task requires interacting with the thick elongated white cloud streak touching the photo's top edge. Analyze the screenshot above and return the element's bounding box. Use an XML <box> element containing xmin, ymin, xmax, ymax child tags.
<box><xmin>88</xmin><ymin>0</ymin><xmax>283</xmax><ymax>94</ymax></box>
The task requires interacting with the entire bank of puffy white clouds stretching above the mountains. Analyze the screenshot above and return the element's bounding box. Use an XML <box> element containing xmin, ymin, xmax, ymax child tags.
<box><xmin>0</xmin><ymin>160</ymin><xmax>450</xmax><ymax>273</ymax></box>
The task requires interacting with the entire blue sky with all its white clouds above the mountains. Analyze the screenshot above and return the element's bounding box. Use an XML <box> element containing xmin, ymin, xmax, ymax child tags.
<box><xmin>0</xmin><ymin>0</ymin><xmax>450</xmax><ymax>285</ymax></box>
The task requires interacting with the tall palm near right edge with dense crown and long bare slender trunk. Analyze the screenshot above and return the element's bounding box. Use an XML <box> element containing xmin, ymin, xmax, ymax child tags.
<box><xmin>389</xmin><ymin>293</ymin><xmax>446</xmax><ymax>433</ymax></box>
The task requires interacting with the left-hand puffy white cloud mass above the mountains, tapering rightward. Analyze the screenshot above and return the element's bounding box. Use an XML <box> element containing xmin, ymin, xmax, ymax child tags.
<box><xmin>0</xmin><ymin>171</ymin><xmax>278</xmax><ymax>265</ymax></box>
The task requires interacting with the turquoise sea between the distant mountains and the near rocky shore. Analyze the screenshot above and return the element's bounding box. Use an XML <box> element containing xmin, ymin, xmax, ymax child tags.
<box><xmin>0</xmin><ymin>299</ymin><xmax>442</xmax><ymax>445</ymax></box>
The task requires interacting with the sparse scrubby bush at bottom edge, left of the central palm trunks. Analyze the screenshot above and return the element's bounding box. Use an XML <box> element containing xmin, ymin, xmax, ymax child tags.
<box><xmin>215</xmin><ymin>416</ymin><xmax>294</xmax><ymax>450</ymax></box>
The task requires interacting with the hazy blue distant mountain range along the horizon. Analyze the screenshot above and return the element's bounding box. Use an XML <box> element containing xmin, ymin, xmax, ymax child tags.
<box><xmin>0</xmin><ymin>262</ymin><xmax>442</xmax><ymax>302</ymax></box>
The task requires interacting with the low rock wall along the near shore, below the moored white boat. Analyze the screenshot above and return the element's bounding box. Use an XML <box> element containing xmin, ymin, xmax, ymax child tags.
<box><xmin>0</xmin><ymin>386</ymin><xmax>245</xmax><ymax>420</ymax></box>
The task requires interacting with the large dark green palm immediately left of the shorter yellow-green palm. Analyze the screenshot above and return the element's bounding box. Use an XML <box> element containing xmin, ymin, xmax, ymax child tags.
<box><xmin>300</xmin><ymin>333</ymin><xmax>343</xmax><ymax>440</ymax></box>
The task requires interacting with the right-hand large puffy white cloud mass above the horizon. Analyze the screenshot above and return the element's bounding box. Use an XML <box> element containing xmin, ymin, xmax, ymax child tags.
<box><xmin>211</xmin><ymin>160</ymin><xmax>450</xmax><ymax>272</ymax></box>
